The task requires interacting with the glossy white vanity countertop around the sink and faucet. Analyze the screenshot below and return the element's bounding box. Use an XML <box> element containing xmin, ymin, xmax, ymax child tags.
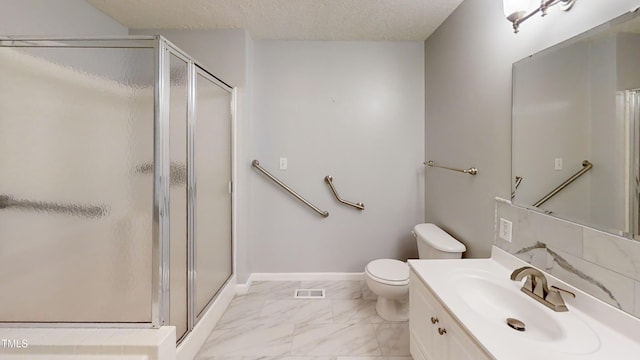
<box><xmin>409</xmin><ymin>247</ymin><xmax>640</xmax><ymax>360</ymax></box>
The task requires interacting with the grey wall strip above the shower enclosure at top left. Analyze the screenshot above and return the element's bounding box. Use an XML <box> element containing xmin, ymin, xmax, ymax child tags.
<box><xmin>0</xmin><ymin>0</ymin><xmax>129</xmax><ymax>37</ymax></box>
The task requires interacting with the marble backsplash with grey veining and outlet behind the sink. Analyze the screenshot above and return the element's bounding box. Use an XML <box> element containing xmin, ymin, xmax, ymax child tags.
<box><xmin>495</xmin><ymin>198</ymin><xmax>640</xmax><ymax>317</ymax></box>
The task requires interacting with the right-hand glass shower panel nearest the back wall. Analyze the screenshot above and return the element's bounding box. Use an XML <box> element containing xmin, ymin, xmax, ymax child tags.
<box><xmin>195</xmin><ymin>70</ymin><xmax>232</xmax><ymax>315</ymax></box>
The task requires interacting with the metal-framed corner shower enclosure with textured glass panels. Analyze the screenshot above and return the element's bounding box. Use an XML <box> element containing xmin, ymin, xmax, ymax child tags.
<box><xmin>0</xmin><ymin>36</ymin><xmax>233</xmax><ymax>339</ymax></box>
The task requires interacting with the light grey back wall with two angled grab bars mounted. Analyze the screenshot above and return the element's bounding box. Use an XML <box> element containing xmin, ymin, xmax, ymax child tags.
<box><xmin>250</xmin><ymin>41</ymin><xmax>424</xmax><ymax>272</ymax></box>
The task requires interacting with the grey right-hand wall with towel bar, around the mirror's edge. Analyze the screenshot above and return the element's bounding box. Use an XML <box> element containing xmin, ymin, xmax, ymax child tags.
<box><xmin>425</xmin><ymin>0</ymin><xmax>640</xmax><ymax>257</ymax></box>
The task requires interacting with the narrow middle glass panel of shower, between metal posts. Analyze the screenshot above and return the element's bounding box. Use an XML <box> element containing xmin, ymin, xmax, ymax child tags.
<box><xmin>169</xmin><ymin>54</ymin><xmax>188</xmax><ymax>339</ymax></box>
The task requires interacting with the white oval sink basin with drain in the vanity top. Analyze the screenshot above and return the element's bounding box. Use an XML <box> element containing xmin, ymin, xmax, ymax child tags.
<box><xmin>451</xmin><ymin>268</ymin><xmax>600</xmax><ymax>354</ymax></box>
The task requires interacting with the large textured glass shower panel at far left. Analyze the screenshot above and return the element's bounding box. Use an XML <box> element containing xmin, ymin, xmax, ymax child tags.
<box><xmin>0</xmin><ymin>47</ymin><xmax>154</xmax><ymax>323</ymax></box>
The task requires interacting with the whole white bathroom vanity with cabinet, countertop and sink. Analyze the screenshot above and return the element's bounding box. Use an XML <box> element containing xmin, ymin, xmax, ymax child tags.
<box><xmin>409</xmin><ymin>247</ymin><xmax>640</xmax><ymax>360</ymax></box>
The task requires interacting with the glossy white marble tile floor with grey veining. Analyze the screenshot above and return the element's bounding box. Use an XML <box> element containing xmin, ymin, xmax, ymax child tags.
<box><xmin>195</xmin><ymin>281</ymin><xmax>411</xmax><ymax>360</ymax></box>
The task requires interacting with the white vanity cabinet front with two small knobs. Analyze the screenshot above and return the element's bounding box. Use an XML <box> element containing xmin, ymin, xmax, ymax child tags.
<box><xmin>409</xmin><ymin>269</ymin><xmax>492</xmax><ymax>360</ymax></box>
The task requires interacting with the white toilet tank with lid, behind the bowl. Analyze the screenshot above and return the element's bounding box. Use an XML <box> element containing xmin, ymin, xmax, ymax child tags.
<box><xmin>413</xmin><ymin>224</ymin><xmax>467</xmax><ymax>259</ymax></box>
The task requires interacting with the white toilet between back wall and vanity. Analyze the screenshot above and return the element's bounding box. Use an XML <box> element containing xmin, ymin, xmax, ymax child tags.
<box><xmin>364</xmin><ymin>224</ymin><xmax>467</xmax><ymax>321</ymax></box>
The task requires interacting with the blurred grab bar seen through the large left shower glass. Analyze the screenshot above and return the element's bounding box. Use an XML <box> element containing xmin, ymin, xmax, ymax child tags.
<box><xmin>0</xmin><ymin>195</ymin><xmax>109</xmax><ymax>218</ymax></box>
